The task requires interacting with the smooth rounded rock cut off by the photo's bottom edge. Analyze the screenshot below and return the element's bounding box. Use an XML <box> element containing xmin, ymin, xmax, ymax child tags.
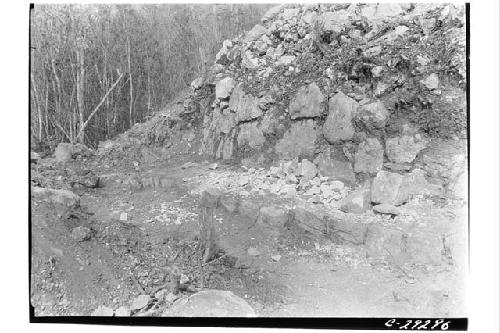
<box><xmin>162</xmin><ymin>290</ymin><xmax>256</xmax><ymax>317</ymax></box>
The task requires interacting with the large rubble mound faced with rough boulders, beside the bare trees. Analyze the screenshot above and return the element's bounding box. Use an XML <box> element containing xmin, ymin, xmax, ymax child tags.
<box><xmin>185</xmin><ymin>4</ymin><xmax>467</xmax><ymax>163</ymax></box>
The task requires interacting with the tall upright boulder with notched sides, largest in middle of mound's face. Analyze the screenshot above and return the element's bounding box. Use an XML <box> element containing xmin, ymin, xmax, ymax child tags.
<box><xmin>323</xmin><ymin>92</ymin><xmax>358</xmax><ymax>144</ymax></box>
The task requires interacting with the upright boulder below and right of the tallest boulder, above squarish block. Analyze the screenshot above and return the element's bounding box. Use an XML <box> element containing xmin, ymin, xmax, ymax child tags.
<box><xmin>354</xmin><ymin>138</ymin><xmax>384</xmax><ymax>174</ymax></box>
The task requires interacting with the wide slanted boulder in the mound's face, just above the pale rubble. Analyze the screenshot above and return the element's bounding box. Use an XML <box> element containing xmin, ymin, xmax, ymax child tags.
<box><xmin>275</xmin><ymin>119</ymin><xmax>318</xmax><ymax>159</ymax></box>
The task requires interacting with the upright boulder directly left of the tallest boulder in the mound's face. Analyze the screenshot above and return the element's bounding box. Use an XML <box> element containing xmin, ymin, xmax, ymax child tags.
<box><xmin>289</xmin><ymin>82</ymin><xmax>324</xmax><ymax>119</ymax></box>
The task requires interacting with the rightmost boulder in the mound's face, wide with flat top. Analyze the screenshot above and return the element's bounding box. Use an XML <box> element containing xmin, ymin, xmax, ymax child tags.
<box><xmin>385</xmin><ymin>134</ymin><xmax>425</xmax><ymax>163</ymax></box>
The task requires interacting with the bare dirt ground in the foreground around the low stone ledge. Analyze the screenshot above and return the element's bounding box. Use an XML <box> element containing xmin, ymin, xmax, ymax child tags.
<box><xmin>31</xmin><ymin>139</ymin><xmax>467</xmax><ymax>317</ymax></box>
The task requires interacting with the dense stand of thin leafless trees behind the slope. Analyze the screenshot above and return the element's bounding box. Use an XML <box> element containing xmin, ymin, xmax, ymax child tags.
<box><xmin>30</xmin><ymin>4</ymin><xmax>269</xmax><ymax>148</ymax></box>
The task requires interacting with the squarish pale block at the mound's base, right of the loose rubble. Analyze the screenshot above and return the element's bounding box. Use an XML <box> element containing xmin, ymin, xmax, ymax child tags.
<box><xmin>371</xmin><ymin>171</ymin><xmax>403</xmax><ymax>205</ymax></box>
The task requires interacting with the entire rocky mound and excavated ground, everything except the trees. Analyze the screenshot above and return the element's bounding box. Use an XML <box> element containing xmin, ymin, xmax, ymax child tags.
<box><xmin>30</xmin><ymin>4</ymin><xmax>468</xmax><ymax>317</ymax></box>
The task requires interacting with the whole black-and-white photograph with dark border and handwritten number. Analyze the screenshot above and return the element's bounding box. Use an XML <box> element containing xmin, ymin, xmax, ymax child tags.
<box><xmin>11</xmin><ymin>2</ymin><xmax>498</xmax><ymax>330</ymax></box>
